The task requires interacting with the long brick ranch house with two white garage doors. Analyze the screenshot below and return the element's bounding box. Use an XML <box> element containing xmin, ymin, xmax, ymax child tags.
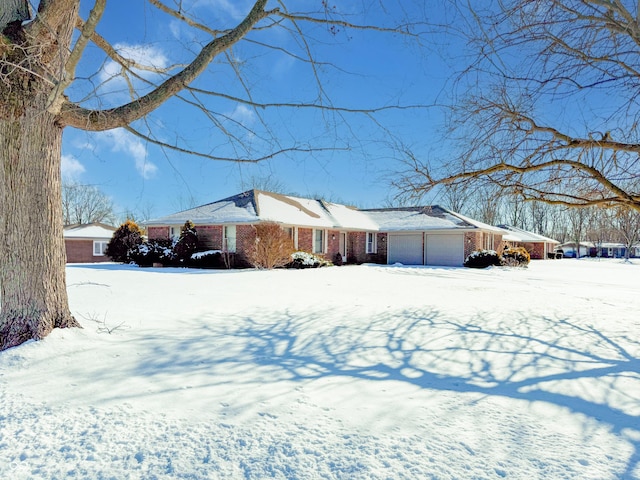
<box><xmin>144</xmin><ymin>190</ymin><xmax>504</xmax><ymax>266</ymax></box>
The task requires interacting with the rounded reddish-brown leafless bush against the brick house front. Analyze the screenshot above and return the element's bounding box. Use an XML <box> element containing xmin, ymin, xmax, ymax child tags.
<box><xmin>248</xmin><ymin>222</ymin><xmax>294</xmax><ymax>269</ymax></box>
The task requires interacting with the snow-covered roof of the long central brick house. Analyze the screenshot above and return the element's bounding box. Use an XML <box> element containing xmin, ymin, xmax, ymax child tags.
<box><xmin>145</xmin><ymin>190</ymin><xmax>504</xmax><ymax>233</ymax></box>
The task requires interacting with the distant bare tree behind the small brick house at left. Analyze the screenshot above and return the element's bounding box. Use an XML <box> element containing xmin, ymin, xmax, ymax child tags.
<box><xmin>62</xmin><ymin>182</ymin><xmax>116</xmax><ymax>225</ymax></box>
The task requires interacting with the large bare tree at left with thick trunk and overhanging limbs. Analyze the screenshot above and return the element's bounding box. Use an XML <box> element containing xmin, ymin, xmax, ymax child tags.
<box><xmin>0</xmin><ymin>0</ymin><xmax>430</xmax><ymax>350</ymax></box>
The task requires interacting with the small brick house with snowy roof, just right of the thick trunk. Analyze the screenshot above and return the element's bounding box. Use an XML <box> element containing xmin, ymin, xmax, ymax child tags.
<box><xmin>64</xmin><ymin>223</ymin><xmax>116</xmax><ymax>263</ymax></box>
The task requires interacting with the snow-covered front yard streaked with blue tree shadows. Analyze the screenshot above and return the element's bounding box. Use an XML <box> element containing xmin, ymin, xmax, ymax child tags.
<box><xmin>0</xmin><ymin>259</ymin><xmax>640</xmax><ymax>480</ymax></box>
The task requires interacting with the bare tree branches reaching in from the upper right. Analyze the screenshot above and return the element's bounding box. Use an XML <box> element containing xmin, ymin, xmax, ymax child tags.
<box><xmin>400</xmin><ymin>0</ymin><xmax>640</xmax><ymax>211</ymax></box>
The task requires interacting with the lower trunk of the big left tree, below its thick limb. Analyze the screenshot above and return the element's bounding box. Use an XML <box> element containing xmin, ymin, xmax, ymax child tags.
<box><xmin>0</xmin><ymin>95</ymin><xmax>79</xmax><ymax>350</ymax></box>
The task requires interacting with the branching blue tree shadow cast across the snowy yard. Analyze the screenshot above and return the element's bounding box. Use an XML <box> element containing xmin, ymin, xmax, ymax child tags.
<box><xmin>131</xmin><ymin>310</ymin><xmax>640</xmax><ymax>478</ymax></box>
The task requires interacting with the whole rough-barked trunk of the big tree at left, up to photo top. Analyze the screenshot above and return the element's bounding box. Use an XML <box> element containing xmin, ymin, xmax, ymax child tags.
<box><xmin>0</xmin><ymin>0</ymin><xmax>80</xmax><ymax>350</ymax></box>
